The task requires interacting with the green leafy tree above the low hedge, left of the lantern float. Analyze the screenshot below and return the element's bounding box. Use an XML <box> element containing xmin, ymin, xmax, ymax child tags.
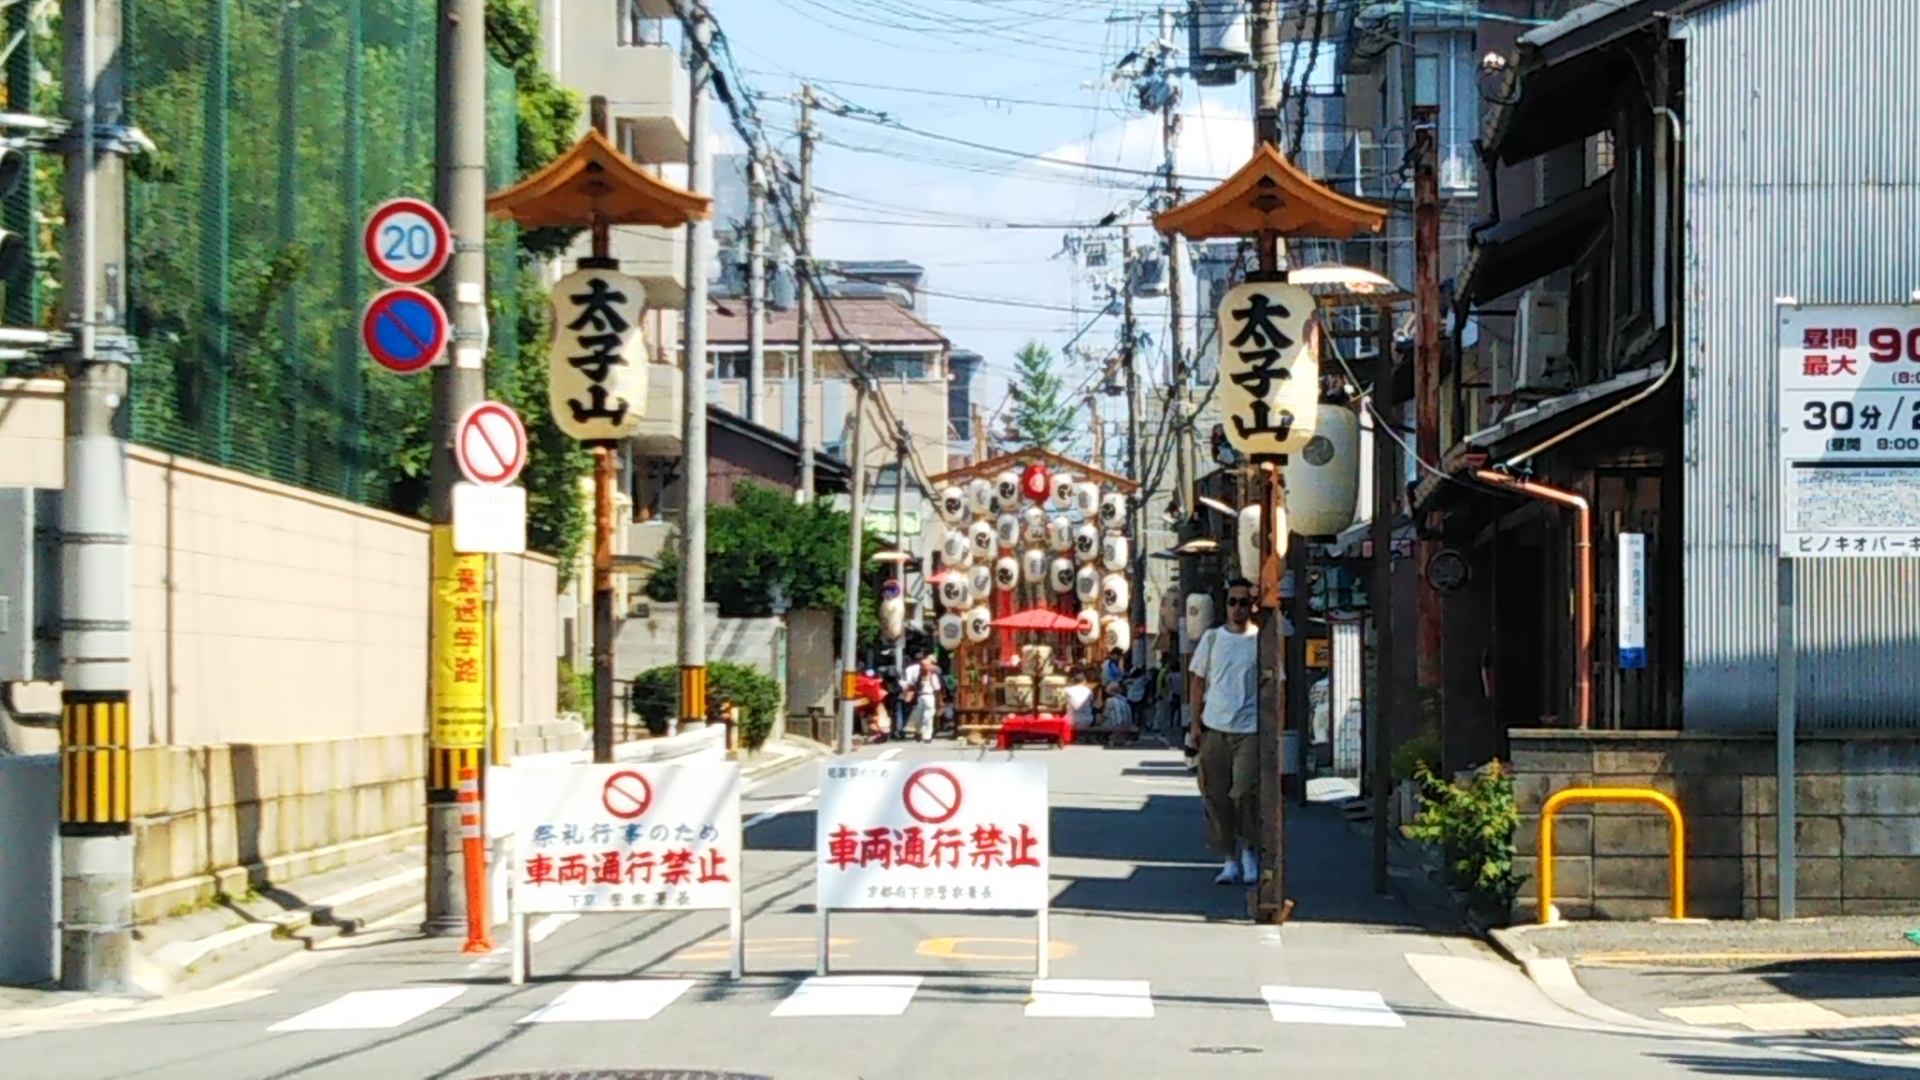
<box><xmin>647</xmin><ymin>480</ymin><xmax>887</xmax><ymax>644</ymax></box>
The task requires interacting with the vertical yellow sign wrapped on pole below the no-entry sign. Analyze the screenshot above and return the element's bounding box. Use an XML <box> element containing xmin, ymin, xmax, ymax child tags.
<box><xmin>428</xmin><ymin>525</ymin><xmax>488</xmax><ymax>749</ymax></box>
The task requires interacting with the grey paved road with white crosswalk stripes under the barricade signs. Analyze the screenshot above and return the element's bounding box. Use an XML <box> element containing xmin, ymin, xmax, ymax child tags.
<box><xmin>0</xmin><ymin>748</ymin><xmax>1920</xmax><ymax>1080</ymax></box>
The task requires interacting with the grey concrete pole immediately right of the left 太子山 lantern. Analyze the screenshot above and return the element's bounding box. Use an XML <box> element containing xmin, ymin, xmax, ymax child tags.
<box><xmin>680</xmin><ymin>0</ymin><xmax>714</xmax><ymax>724</ymax></box>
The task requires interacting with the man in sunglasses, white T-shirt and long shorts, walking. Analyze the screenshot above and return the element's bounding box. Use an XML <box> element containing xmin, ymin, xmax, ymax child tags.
<box><xmin>1187</xmin><ymin>578</ymin><xmax>1260</xmax><ymax>886</ymax></box>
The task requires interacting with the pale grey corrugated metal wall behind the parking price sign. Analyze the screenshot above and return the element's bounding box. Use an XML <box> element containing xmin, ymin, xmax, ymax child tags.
<box><xmin>1676</xmin><ymin>0</ymin><xmax>1920</xmax><ymax>730</ymax></box>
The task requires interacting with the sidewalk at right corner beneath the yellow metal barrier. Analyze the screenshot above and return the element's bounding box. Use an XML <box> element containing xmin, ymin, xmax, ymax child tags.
<box><xmin>1492</xmin><ymin>917</ymin><xmax>1920</xmax><ymax>1047</ymax></box>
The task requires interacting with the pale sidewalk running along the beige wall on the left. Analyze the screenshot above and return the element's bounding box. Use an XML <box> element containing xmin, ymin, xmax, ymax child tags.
<box><xmin>0</xmin><ymin>740</ymin><xmax>829</xmax><ymax>1006</ymax></box>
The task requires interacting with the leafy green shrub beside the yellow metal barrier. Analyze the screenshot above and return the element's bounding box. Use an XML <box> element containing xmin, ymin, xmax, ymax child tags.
<box><xmin>1405</xmin><ymin>761</ymin><xmax>1526</xmax><ymax>922</ymax></box>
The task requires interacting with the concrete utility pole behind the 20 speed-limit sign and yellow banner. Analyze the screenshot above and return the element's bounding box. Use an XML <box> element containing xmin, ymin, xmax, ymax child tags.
<box><xmin>420</xmin><ymin>0</ymin><xmax>488</xmax><ymax>936</ymax></box>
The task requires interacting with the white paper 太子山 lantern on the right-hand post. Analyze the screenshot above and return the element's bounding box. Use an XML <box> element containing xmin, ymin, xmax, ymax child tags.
<box><xmin>1217</xmin><ymin>281</ymin><xmax>1319</xmax><ymax>459</ymax></box>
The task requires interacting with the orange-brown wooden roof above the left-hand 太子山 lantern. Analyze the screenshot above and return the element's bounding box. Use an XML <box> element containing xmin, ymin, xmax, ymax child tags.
<box><xmin>486</xmin><ymin>129</ymin><xmax>714</xmax><ymax>229</ymax></box>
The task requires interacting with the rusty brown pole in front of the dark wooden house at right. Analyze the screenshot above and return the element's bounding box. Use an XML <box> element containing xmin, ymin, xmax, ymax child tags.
<box><xmin>1413</xmin><ymin>106</ymin><xmax>1457</xmax><ymax>769</ymax></box>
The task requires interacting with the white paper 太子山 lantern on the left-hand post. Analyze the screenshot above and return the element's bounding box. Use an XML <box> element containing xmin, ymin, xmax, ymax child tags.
<box><xmin>547</xmin><ymin>269</ymin><xmax>647</xmax><ymax>442</ymax></box>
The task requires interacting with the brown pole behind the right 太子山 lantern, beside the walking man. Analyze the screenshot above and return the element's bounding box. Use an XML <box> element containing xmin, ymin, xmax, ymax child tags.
<box><xmin>1252</xmin><ymin>0</ymin><xmax>1300</xmax><ymax>922</ymax></box>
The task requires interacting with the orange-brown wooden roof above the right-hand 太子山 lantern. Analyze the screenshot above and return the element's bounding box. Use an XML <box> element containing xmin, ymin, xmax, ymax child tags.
<box><xmin>1154</xmin><ymin>142</ymin><xmax>1386</xmax><ymax>240</ymax></box>
